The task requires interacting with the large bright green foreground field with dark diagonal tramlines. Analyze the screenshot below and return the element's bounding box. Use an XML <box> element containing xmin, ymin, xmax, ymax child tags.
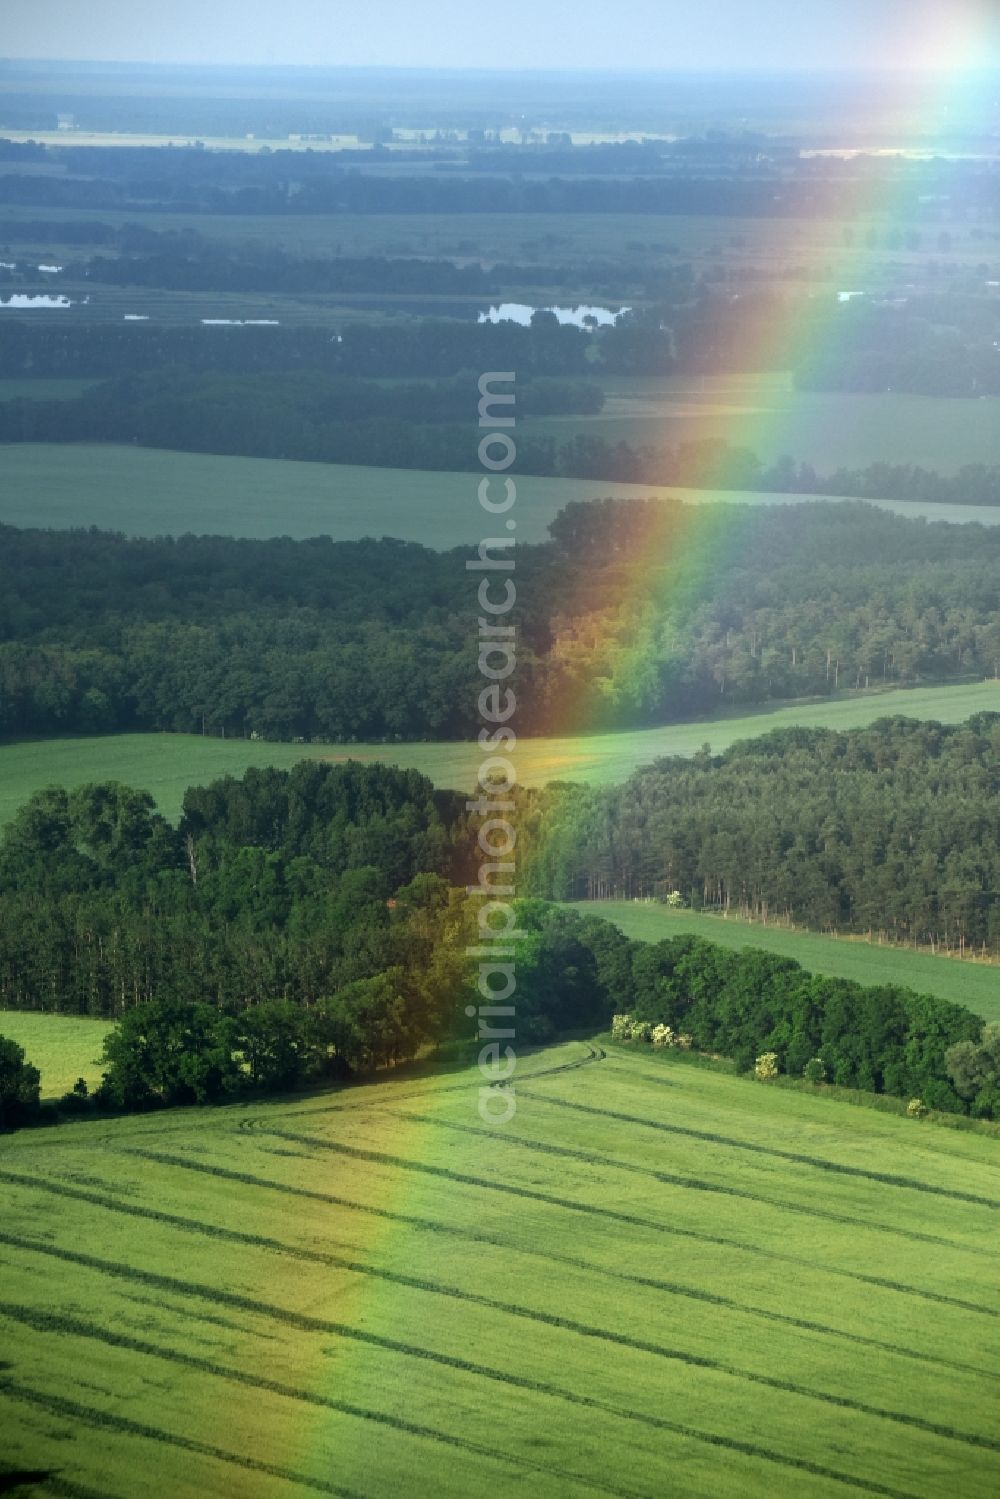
<box><xmin>0</xmin><ymin>1043</ymin><xmax>1000</xmax><ymax>1499</ymax></box>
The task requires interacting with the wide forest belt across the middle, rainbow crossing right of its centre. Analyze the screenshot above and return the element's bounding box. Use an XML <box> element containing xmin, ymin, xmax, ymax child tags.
<box><xmin>0</xmin><ymin>501</ymin><xmax>1000</xmax><ymax>741</ymax></box>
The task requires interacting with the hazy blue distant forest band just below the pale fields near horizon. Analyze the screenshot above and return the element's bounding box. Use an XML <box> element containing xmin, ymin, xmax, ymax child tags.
<box><xmin>0</xmin><ymin>145</ymin><xmax>994</xmax><ymax>222</ymax></box>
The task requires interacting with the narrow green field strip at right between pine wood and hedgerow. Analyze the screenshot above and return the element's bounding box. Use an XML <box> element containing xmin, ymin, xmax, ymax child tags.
<box><xmin>573</xmin><ymin>901</ymin><xmax>1000</xmax><ymax>1021</ymax></box>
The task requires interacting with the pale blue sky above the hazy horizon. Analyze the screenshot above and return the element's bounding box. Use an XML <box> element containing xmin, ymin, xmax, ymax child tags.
<box><xmin>0</xmin><ymin>0</ymin><xmax>1000</xmax><ymax>70</ymax></box>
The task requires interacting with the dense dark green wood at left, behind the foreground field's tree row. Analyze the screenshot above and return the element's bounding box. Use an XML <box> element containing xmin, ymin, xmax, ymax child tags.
<box><xmin>0</xmin><ymin>761</ymin><xmax>466</xmax><ymax>1025</ymax></box>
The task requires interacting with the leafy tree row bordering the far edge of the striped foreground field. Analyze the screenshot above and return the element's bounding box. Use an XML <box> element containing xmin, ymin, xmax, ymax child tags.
<box><xmin>0</xmin><ymin>875</ymin><xmax>1000</xmax><ymax>1127</ymax></box>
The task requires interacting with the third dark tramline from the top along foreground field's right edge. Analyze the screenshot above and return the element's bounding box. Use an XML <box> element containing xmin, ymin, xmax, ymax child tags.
<box><xmin>257</xmin><ymin>1129</ymin><xmax>1000</xmax><ymax>1318</ymax></box>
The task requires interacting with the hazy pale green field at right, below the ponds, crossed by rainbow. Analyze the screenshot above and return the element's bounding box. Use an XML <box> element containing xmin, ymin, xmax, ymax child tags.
<box><xmin>522</xmin><ymin>373</ymin><xmax>1000</xmax><ymax>470</ymax></box>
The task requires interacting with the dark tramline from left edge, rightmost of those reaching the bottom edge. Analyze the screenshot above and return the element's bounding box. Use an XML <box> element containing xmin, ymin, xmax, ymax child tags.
<box><xmin>0</xmin><ymin>1232</ymin><xmax>918</xmax><ymax>1499</ymax></box>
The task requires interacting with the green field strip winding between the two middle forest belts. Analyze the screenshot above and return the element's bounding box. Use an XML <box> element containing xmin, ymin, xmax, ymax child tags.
<box><xmin>0</xmin><ymin>681</ymin><xmax>1000</xmax><ymax>823</ymax></box>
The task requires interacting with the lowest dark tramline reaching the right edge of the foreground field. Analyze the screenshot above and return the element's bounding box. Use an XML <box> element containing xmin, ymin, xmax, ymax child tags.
<box><xmin>0</xmin><ymin>1217</ymin><xmax>1000</xmax><ymax>1453</ymax></box>
